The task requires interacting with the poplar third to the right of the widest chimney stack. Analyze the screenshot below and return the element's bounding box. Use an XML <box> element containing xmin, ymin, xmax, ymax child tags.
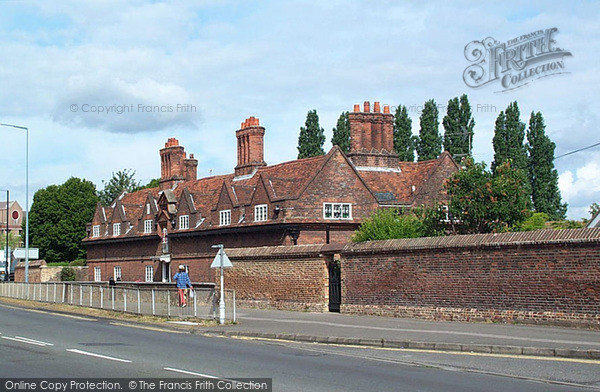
<box><xmin>442</xmin><ymin>94</ymin><xmax>475</xmax><ymax>157</ymax></box>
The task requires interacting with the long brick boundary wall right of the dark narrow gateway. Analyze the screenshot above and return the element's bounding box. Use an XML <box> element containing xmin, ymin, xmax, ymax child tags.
<box><xmin>341</xmin><ymin>229</ymin><xmax>600</xmax><ymax>327</ymax></box>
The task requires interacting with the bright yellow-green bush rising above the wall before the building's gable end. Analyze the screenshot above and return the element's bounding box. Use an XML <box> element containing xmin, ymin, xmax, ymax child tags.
<box><xmin>352</xmin><ymin>208</ymin><xmax>426</xmax><ymax>242</ymax></box>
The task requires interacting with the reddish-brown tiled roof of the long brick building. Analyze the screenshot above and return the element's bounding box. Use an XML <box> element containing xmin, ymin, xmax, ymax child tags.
<box><xmin>92</xmin><ymin>147</ymin><xmax>453</xmax><ymax>240</ymax></box>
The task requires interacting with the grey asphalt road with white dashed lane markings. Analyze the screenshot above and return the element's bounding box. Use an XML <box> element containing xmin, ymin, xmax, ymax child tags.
<box><xmin>0</xmin><ymin>304</ymin><xmax>600</xmax><ymax>392</ymax></box>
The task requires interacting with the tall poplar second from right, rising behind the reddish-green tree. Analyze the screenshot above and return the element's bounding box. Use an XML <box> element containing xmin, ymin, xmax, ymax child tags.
<box><xmin>492</xmin><ymin>101</ymin><xmax>527</xmax><ymax>173</ymax></box>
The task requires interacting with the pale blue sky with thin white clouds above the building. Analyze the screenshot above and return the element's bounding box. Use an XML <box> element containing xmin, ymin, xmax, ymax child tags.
<box><xmin>0</xmin><ymin>0</ymin><xmax>600</xmax><ymax>219</ymax></box>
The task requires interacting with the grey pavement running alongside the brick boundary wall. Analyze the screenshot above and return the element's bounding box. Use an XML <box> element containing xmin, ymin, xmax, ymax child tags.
<box><xmin>196</xmin><ymin>308</ymin><xmax>600</xmax><ymax>360</ymax></box>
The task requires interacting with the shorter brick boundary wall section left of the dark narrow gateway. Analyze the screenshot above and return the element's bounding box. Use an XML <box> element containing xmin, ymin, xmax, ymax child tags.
<box><xmin>224</xmin><ymin>245</ymin><xmax>329</xmax><ymax>312</ymax></box>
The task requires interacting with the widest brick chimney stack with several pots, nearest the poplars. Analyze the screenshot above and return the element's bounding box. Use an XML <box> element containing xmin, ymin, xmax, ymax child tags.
<box><xmin>348</xmin><ymin>101</ymin><xmax>396</xmax><ymax>166</ymax></box>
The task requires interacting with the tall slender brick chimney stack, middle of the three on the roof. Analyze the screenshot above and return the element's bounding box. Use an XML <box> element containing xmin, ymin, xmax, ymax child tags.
<box><xmin>235</xmin><ymin>117</ymin><xmax>267</xmax><ymax>177</ymax></box>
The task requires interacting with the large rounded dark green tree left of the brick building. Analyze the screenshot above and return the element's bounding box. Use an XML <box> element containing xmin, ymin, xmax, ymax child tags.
<box><xmin>28</xmin><ymin>177</ymin><xmax>98</xmax><ymax>263</ymax></box>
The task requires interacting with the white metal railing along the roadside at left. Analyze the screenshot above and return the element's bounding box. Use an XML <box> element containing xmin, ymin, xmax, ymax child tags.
<box><xmin>0</xmin><ymin>282</ymin><xmax>237</xmax><ymax>322</ymax></box>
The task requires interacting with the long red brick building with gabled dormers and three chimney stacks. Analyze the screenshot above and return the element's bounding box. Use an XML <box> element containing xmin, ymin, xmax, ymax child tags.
<box><xmin>84</xmin><ymin>102</ymin><xmax>459</xmax><ymax>281</ymax></box>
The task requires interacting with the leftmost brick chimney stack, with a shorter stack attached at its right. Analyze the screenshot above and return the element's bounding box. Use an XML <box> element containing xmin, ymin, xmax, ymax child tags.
<box><xmin>160</xmin><ymin>137</ymin><xmax>198</xmax><ymax>189</ymax></box>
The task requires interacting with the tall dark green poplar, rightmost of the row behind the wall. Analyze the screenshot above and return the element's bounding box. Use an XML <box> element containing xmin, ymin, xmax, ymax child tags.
<box><xmin>527</xmin><ymin>112</ymin><xmax>567</xmax><ymax>220</ymax></box>
